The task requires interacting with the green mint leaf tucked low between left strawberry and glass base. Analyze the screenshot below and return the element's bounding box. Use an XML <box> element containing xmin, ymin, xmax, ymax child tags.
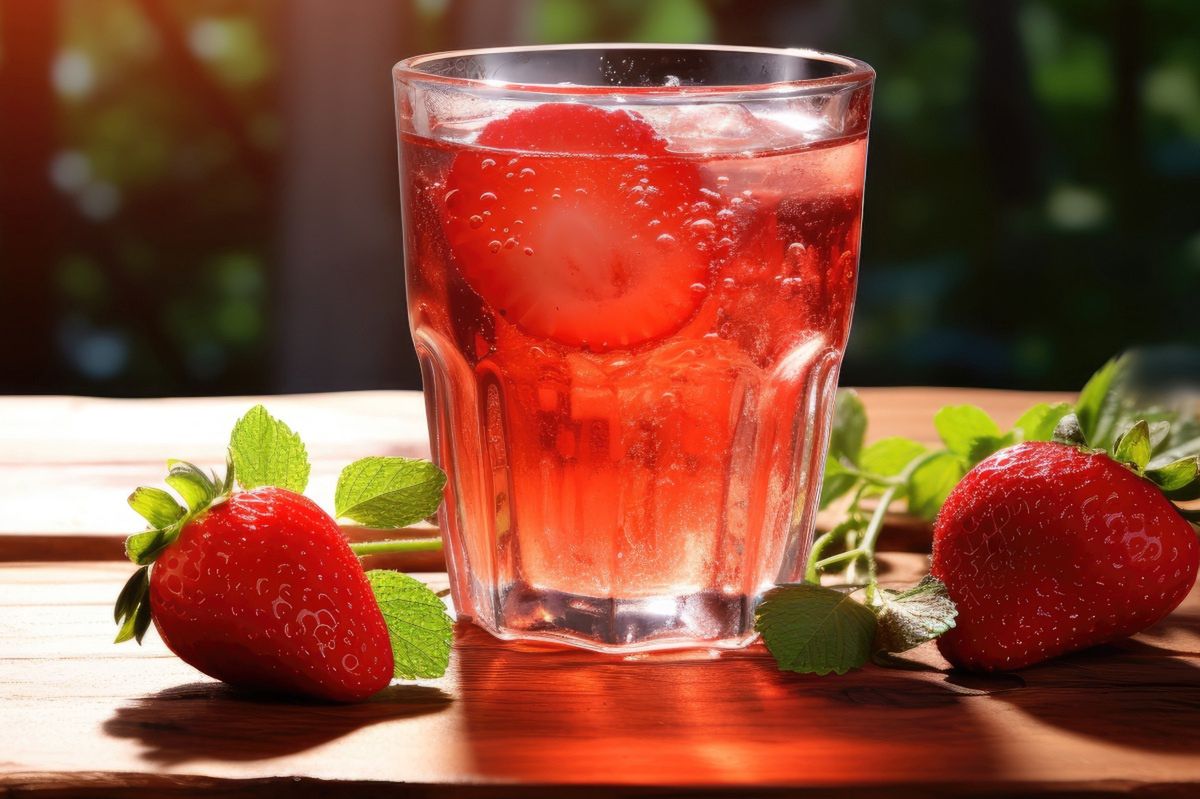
<box><xmin>367</xmin><ymin>569</ymin><xmax>454</xmax><ymax>680</ymax></box>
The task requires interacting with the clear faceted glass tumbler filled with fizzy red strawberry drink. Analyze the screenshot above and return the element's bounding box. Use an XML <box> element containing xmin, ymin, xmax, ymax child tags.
<box><xmin>394</xmin><ymin>44</ymin><xmax>874</xmax><ymax>651</ymax></box>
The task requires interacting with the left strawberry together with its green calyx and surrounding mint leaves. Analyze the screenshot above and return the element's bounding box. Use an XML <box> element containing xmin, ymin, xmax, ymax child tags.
<box><xmin>115</xmin><ymin>405</ymin><xmax>451</xmax><ymax>701</ymax></box>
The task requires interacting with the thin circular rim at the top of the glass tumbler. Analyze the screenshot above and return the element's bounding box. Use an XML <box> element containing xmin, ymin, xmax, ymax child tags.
<box><xmin>391</xmin><ymin>42</ymin><xmax>875</xmax><ymax>103</ymax></box>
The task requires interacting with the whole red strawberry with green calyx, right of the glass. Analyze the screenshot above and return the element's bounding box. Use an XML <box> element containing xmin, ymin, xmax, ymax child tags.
<box><xmin>932</xmin><ymin>417</ymin><xmax>1200</xmax><ymax>671</ymax></box>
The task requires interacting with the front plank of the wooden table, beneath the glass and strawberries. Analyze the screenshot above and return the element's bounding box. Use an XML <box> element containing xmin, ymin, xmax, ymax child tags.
<box><xmin>0</xmin><ymin>555</ymin><xmax>1200</xmax><ymax>797</ymax></box>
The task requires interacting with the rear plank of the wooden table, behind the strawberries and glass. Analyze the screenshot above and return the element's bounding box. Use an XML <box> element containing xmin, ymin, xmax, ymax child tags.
<box><xmin>0</xmin><ymin>389</ymin><xmax>1067</xmax><ymax>559</ymax></box>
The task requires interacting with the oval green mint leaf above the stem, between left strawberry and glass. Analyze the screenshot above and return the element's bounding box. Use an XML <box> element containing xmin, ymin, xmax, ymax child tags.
<box><xmin>334</xmin><ymin>457</ymin><xmax>446</xmax><ymax>528</ymax></box>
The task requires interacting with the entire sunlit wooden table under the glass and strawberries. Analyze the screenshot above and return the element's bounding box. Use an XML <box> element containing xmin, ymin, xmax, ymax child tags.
<box><xmin>0</xmin><ymin>389</ymin><xmax>1200</xmax><ymax>798</ymax></box>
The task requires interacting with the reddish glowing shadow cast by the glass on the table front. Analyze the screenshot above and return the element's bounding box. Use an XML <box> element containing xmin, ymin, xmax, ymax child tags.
<box><xmin>455</xmin><ymin>624</ymin><xmax>1003</xmax><ymax>786</ymax></box>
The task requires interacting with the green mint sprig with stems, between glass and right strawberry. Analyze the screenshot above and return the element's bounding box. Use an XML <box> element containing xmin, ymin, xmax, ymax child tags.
<box><xmin>756</xmin><ymin>358</ymin><xmax>1200</xmax><ymax>674</ymax></box>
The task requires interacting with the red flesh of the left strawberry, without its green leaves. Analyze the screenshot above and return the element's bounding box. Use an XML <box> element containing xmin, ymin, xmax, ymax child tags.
<box><xmin>129</xmin><ymin>479</ymin><xmax>392</xmax><ymax>702</ymax></box>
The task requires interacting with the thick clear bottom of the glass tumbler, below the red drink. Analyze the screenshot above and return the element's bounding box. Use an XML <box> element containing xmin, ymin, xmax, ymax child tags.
<box><xmin>474</xmin><ymin>583</ymin><xmax>758</xmax><ymax>654</ymax></box>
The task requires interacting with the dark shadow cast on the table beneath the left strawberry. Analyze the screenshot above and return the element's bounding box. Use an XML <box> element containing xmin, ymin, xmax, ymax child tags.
<box><xmin>103</xmin><ymin>683</ymin><xmax>451</xmax><ymax>764</ymax></box>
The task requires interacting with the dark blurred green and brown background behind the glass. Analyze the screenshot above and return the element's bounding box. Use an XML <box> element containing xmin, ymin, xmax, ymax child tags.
<box><xmin>0</xmin><ymin>0</ymin><xmax>1200</xmax><ymax>396</ymax></box>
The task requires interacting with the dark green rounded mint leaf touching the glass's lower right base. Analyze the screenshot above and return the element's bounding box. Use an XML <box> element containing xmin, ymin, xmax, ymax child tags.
<box><xmin>755</xmin><ymin>583</ymin><xmax>875</xmax><ymax>674</ymax></box>
